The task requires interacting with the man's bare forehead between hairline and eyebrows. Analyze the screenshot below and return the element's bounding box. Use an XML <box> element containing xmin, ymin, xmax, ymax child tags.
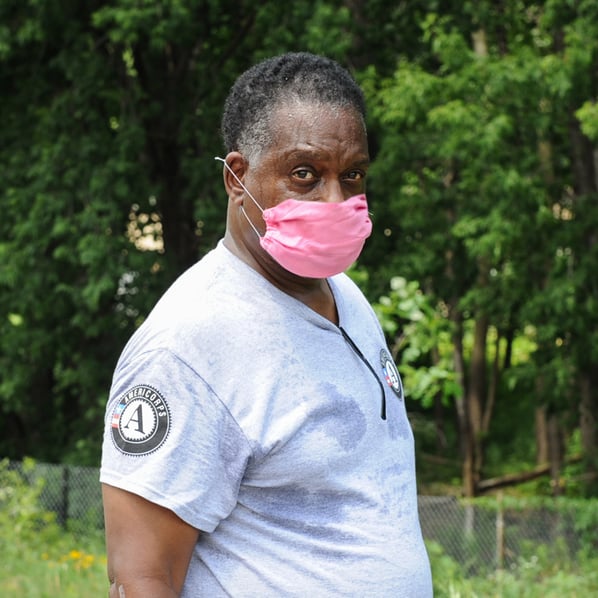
<box><xmin>265</xmin><ymin>101</ymin><xmax>367</xmax><ymax>159</ymax></box>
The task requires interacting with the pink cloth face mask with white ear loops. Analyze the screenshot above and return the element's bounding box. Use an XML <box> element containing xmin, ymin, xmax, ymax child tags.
<box><xmin>216</xmin><ymin>158</ymin><xmax>372</xmax><ymax>278</ymax></box>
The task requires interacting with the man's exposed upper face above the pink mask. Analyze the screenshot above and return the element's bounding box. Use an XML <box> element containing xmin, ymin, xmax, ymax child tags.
<box><xmin>244</xmin><ymin>102</ymin><xmax>369</xmax><ymax>233</ymax></box>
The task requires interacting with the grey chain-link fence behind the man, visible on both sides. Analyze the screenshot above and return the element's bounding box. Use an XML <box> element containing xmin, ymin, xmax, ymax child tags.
<box><xmin>12</xmin><ymin>463</ymin><xmax>598</xmax><ymax>574</ymax></box>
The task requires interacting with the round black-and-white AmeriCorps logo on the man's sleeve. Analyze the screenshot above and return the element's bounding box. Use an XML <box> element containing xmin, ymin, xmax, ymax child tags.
<box><xmin>111</xmin><ymin>384</ymin><xmax>170</xmax><ymax>456</ymax></box>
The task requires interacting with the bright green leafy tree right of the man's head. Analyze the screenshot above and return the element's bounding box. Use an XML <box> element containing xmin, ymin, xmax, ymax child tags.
<box><xmin>366</xmin><ymin>1</ymin><xmax>598</xmax><ymax>495</ymax></box>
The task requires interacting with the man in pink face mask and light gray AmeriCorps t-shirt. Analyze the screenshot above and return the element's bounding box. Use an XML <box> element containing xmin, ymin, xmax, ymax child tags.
<box><xmin>101</xmin><ymin>53</ymin><xmax>432</xmax><ymax>598</ymax></box>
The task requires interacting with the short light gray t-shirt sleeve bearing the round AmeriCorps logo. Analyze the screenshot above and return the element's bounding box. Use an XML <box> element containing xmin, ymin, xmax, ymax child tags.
<box><xmin>100</xmin><ymin>350</ymin><xmax>250</xmax><ymax>532</ymax></box>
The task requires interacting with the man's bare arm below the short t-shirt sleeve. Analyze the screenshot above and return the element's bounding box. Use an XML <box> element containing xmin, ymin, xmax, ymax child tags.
<box><xmin>102</xmin><ymin>484</ymin><xmax>199</xmax><ymax>598</ymax></box>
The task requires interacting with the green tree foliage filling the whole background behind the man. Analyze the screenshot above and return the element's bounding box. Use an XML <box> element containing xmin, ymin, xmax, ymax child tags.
<box><xmin>0</xmin><ymin>0</ymin><xmax>598</xmax><ymax>500</ymax></box>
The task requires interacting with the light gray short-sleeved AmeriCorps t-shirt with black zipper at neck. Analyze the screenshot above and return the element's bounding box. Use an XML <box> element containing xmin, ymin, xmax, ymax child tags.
<box><xmin>101</xmin><ymin>244</ymin><xmax>432</xmax><ymax>598</ymax></box>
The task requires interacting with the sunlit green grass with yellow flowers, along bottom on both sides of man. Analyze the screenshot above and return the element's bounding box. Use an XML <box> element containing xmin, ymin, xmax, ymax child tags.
<box><xmin>0</xmin><ymin>529</ymin><xmax>598</xmax><ymax>598</ymax></box>
